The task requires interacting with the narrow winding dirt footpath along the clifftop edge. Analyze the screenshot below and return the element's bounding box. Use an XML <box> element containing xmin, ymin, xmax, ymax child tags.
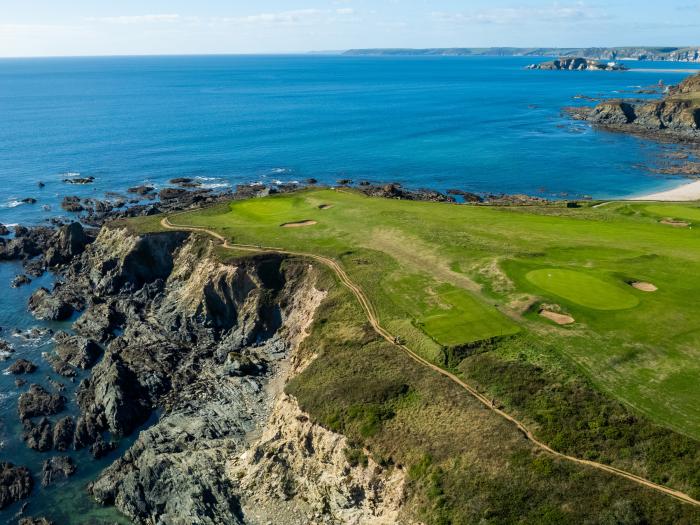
<box><xmin>160</xmin><ymin>217</ymin><xmax>700</xmax><ymax>507</ymax></box>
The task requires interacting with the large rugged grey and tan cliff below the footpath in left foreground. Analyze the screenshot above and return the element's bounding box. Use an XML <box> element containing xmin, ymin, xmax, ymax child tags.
<box><xmin>31</xmin><ymin>227</ymin><xmax>404</xmax><ymax>524</ymax></box>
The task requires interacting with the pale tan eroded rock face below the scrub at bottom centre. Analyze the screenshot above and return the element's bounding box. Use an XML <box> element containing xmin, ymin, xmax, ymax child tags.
<box><xmin>227</xmin><ymin>395</ymin><xmax>406</xmax><ymax>525</ymax></box>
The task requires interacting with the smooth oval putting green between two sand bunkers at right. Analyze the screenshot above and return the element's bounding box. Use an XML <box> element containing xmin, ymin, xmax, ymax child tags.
<box><xmin>526</xmin><ymin>268</ymin><xmax>639</xmax><ymax>310</ymax></box>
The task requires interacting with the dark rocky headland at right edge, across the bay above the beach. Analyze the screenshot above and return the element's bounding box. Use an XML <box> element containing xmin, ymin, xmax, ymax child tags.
<box><xmin>570</xmin><ymin>75</ymin><xmax>700</xmax><ymax>141</ymax></box>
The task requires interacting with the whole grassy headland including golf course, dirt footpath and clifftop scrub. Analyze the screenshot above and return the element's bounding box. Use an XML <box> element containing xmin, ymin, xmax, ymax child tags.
<box><xmin>127</xmin><ymin>188</ymin><xmax>700</xmax><ymax>523</ymax></box>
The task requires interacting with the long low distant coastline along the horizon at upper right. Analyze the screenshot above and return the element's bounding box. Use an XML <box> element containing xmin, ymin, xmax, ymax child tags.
<box><xmin>344</xmin><ymin>47</ymin><xmax>700</xmax><ymax>62</ymax></box>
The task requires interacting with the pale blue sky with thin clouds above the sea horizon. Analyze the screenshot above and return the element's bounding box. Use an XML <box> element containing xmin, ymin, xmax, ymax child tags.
<box><xmin>0</xmin><ymin>0</ymin><xmax>700</xmax><ymax>57</ymax></box>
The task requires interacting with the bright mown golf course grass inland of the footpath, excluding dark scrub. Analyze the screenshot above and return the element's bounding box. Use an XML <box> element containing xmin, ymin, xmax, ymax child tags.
<box><xmin>141</xmin><ymin>190</ymin><xmax>700</xmax><ymax>439</ymax></box>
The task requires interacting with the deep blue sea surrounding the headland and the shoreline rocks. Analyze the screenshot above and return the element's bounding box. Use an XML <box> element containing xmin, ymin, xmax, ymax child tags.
<box><xmin>0</xmin><ymin>56</ymin><xmax>692</xmax><ymax>523</ymax></box>
